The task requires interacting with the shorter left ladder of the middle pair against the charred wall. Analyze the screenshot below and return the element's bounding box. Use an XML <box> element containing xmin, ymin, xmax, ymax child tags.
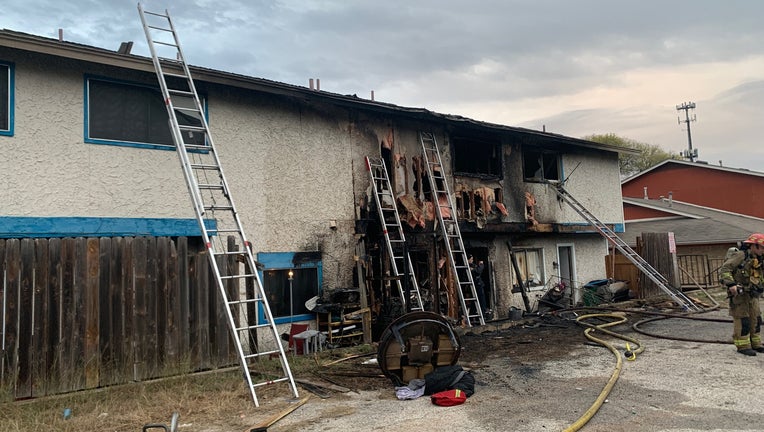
<box><xmin>366</xmin><ymin>156</ymin><xmax>424</xmax><ymax>312</ymax></box>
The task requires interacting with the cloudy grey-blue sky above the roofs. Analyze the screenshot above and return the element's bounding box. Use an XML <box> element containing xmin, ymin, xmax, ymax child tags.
<box><xmin>0</xmin><ymin>0</ymin><xmax>764</xmax><ymax>172</ymax></box>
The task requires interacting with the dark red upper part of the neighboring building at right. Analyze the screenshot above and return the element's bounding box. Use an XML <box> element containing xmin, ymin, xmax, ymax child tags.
<box><xmin>621</xmin><ymin>159</ymin><xmax>764</xmax><ymax>218</ymax></box>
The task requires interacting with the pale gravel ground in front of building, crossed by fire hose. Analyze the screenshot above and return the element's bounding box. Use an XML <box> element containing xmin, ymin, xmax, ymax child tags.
<box><xmin>268</xmin><ymin>310</ymin><xmax>764</xmax><ymax>432</ymax></box>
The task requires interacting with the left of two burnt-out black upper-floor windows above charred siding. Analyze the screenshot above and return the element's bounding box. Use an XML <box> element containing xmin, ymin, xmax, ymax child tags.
<box><xmin>451</xmin><ymin>136</ymin><xmax>502</xmax><ymax>178</ymax></box>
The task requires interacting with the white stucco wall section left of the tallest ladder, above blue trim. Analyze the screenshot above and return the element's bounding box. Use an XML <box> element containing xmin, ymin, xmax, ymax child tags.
<box><xmin>0</xmin><ymin>56</ymin><xmax>193</xmax><ymax>218</ymax></box>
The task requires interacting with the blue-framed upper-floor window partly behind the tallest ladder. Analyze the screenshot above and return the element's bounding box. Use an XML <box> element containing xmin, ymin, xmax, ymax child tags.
<box><xmin>85</xmin><ymin>77</ymin><xmax>205</xmax><ymax>149</ymax></box>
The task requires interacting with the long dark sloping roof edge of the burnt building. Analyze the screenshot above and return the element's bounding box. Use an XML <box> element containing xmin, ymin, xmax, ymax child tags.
<box><xmin>0</xmin><ymin>29</ymin><xmax>638</xmax><ymax>154</ymax></box>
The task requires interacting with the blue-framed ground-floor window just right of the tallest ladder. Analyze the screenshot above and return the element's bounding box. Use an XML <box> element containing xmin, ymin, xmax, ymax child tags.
<box><xmin>257</xmin><ymin>252</ymin><xmax>322</xmax><ymax>324</ymax></box>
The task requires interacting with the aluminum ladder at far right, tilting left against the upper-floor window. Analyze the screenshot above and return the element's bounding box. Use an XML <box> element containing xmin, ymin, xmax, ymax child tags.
<box><xmin>548</xmin><ymin>182</ymin><xmax>702</xmax><ymax>312</ymax></box>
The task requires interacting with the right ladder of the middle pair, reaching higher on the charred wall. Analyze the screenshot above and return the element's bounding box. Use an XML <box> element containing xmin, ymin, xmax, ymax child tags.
<box><xmin>419</xmin><ymin>132</ymin><xmax>485</xmax><ymax>326</ymax></box>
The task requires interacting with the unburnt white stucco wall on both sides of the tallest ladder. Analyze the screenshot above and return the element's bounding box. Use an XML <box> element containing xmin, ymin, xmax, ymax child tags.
<box><xmin>0</xmin><ymin>52</ymin><xmax>379</xmax><ymax>288</ymax></box>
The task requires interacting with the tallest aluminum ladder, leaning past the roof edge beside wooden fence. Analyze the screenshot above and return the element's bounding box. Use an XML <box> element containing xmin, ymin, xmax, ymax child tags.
<box><xmin>138</xmin><ymin>3</ymin><xmax>298</xmax><ymax>406</ymax></box>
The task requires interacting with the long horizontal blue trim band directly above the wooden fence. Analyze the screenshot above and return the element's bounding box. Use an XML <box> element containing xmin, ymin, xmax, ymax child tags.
<box><xmin>0</xmin><ymin>216</ymin><xmax>217</xmax><ymax>238</ymax></box>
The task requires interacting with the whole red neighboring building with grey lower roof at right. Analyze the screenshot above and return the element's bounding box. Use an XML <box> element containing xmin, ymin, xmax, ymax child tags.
<box><xmin>621</xmin><ymin>159</ymin><xmax>764</xmax><ymax>286</ymax></box>
